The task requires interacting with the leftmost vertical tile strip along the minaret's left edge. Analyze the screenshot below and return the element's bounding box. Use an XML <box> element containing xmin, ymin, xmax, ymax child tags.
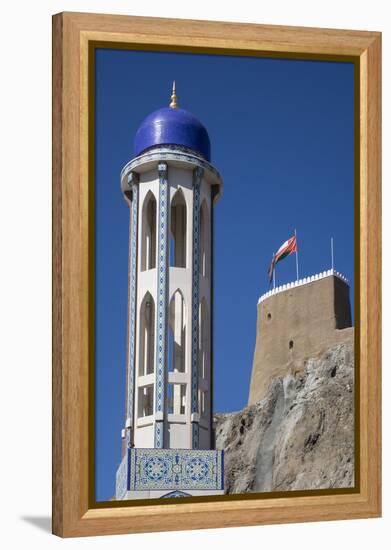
<box><xmin>126</xmin><ymin>172</ymin><xmax>139</xmax><ymax>446</ymax></box>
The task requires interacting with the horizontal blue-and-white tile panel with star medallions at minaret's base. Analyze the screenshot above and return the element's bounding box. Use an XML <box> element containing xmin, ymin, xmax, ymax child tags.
<box><xmin>127</xmin><ymin>448</ymin><xmax>224</xmax><ymax>491</ymax></box>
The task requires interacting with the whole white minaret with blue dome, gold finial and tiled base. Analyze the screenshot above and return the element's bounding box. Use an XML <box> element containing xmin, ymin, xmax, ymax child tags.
<box><xmin>116</xmin><ymin>82</ymin><xmax>223</xmax><ymax>499</ymax></box>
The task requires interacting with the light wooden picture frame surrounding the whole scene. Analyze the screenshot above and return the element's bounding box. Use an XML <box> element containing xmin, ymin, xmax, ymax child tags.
<box><xmin>53</xmin><ymin>13</ymin><xmax>381</xmax><ymax>537</ymax></box>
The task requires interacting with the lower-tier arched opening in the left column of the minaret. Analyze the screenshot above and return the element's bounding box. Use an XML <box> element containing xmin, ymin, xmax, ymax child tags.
<box><xmin>139</xmin><ymin>292</ymin><xmax>155</xmax><ymax>376</ymax></box>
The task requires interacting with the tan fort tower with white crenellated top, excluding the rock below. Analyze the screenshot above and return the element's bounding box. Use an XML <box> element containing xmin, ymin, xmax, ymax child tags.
<box><xmin>248</xmin><ymin>270</ymin><xmax>354</xmax><ymax>405</ymax></box>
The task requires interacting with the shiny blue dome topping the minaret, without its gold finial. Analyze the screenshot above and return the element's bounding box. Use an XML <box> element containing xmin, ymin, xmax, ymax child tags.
<box><xmin>134</xmin><ymin>107</ymin><xmax>210</xmax><ymax>161</ymax></box>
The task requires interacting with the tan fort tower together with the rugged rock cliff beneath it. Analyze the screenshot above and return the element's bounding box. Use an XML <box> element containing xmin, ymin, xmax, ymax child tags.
<box><xmin>214</xmin><ymin>269</ymin><xmax>355</xmax><ymax>494</ymax></box>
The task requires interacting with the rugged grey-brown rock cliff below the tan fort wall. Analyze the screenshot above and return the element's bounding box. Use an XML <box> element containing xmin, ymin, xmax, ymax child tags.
<box><xmin>215</xmin><ymin>335</ymin><xmax>354</xmax><ymax>494</ymax></box>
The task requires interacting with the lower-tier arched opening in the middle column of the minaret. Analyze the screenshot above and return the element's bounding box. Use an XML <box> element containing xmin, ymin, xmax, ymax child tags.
<box><xmin>168</xmin><ymin>290</ymin><xmax>186</xmax><ymax>372</ymax></box>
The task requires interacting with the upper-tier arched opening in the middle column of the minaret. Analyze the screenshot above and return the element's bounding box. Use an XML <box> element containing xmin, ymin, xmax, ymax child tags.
<box><xmin>170</xmin><ymin>189</ymin><xmax>186</xmax><ymax>267</ymax></box>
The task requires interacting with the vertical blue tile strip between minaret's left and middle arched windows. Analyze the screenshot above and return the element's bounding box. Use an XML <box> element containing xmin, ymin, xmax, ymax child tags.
<box><xmin>155</xmin><ymin>162</ymin><xmax>170</xmax><ymax>449</ymax></box>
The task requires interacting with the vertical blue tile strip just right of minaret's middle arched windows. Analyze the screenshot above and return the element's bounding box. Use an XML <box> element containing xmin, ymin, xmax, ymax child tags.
<box><xmin>191</xmin><ymin>166</ymin><xmax>204</xmax><ymax>449</ymax></box>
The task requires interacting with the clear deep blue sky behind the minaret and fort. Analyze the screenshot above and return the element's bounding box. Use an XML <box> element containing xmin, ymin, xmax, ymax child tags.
<box><xmin>95</xmin><ymin>49</ymin><xmax>354</xmax><ymax>500</ymax></box>
